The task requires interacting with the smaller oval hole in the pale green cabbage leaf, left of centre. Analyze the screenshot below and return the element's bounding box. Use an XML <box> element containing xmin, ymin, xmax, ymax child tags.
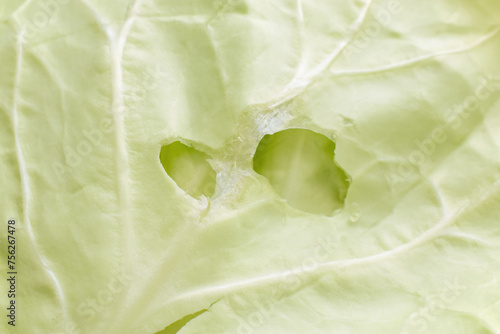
<box><xmin>160</xmin><ymin>141</ymin><xmax>216</xmax><ymax>198</ymax></box>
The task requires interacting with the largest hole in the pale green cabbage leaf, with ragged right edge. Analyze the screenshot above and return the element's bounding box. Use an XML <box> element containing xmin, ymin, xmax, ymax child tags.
<box><xmin>253</xmin><ymin>129</ymin><xmax>349</xmax><ymax>215</ymax></box>
